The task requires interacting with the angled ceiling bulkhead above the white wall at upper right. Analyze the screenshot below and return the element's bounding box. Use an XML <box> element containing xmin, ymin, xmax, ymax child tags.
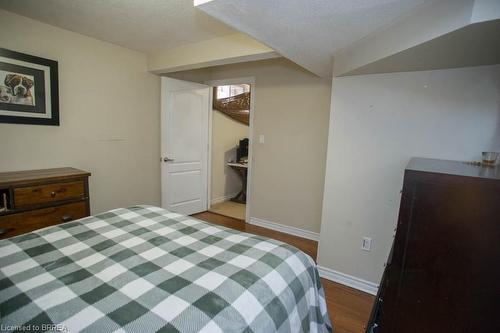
<box><xmin>333</xmin><ymin>0</ymin><xmax>500</xmax><ymax>76</ymax></box>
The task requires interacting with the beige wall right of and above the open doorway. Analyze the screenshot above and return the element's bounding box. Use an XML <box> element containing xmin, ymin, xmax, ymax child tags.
<box><xmin>169</xmin><ymin>58</ymin><xmax>331</xmax><ymax>232</ymax></box>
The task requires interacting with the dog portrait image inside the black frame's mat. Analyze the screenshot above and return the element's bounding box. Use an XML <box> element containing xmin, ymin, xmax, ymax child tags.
<box><xmin>0</xmin><ymin>70</ymin><xmax>35</xmax><ymax>105</ymax></box>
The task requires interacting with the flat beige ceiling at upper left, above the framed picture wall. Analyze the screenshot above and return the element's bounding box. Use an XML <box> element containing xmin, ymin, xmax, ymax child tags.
<box><xmin>0</xmin><ymin>0</ymin><xmax>236</xmax><ymax>53</ymax></box>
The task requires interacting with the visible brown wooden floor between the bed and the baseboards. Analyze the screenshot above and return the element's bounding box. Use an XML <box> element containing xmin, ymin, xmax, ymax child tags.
<box><xmin>193</xmin><ymin>212</ymin><xmax>374</xmax><ymax>333</ymax></box>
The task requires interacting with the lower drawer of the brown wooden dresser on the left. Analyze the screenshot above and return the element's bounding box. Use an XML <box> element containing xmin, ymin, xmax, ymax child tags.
<box><xmin>0</xmin><ymin>201</ymin><xmax>87</xmax><ymax>239</ymax></box>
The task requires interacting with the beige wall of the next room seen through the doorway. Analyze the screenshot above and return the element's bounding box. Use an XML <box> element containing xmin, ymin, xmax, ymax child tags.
<box><xmin>211</xmin><ymin>110</ymin><xmax>248</xmax><ymax>203</ymax></box>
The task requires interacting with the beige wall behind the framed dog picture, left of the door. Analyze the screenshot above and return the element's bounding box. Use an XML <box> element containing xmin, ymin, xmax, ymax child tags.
<box><xmin>0</xmin><ymin>10</ymin><xmax>160</xmax><ymax>213</ymax></box>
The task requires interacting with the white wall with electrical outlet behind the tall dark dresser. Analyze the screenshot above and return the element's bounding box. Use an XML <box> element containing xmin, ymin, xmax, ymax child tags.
<box><xmin>319</xmin><ymin>65</ymin><xmax>500</xmax><ymax>283</ymax></box>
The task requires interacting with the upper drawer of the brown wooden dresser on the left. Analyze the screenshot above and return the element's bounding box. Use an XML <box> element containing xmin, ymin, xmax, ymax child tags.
<box><xmin>14</xmin><ymin>180</ymin><xmax>85</xmax><ymax>209</ymax></box>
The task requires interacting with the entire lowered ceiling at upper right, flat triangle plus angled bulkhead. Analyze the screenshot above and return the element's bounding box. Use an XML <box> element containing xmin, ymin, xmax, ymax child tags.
<box><xmin>197</xmin><ymin>0</ymin><xmax>500</xmax><ymax>76</ymax></box>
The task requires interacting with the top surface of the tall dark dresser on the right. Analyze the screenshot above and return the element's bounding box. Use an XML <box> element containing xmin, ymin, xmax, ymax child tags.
<box><xmin>406</xmin><ymin>157</ymin><xmax>500</xmax><ymax>180</ymax></box>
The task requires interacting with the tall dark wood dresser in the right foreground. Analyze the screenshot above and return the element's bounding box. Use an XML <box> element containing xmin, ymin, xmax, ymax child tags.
<box><xmin>367</xmin><ymin>158</ymin><xmax>500</xmax><ymax>333</ymax></box>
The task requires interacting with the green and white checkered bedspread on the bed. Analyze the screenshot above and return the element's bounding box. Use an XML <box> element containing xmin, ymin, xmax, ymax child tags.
<box><xmin>0</xmin><ymin>206</ymin><xmax>331</xmax><ymax>332</ymax></box>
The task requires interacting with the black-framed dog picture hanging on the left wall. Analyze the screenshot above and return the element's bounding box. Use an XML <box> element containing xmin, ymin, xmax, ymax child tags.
<box><xmin>0</xmin><ymin>48</ymin><xmax>59</xmax><ymax>126</ymax></box>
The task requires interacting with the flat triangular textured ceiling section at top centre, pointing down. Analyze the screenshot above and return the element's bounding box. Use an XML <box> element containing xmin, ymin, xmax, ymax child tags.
<box><xmin>197</xmin><ymin>0</ymin><xmax>432</xmax><ymax>76</ymax></box>
